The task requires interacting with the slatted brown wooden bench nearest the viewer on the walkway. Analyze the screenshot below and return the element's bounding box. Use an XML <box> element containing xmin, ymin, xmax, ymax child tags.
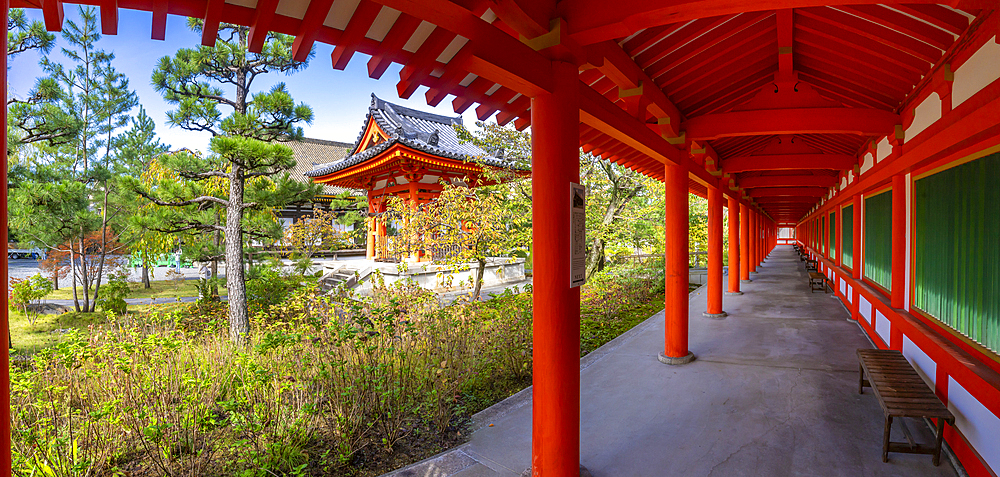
<box><xmin>858</xmin><ymin>349</ymin><xmax>955</xmax><ymax>465</ymax></box>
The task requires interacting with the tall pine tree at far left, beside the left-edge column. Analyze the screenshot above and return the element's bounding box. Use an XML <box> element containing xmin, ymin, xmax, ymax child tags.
<box><xmin>11</xmin><ymin>7</ymin><xmax>138</xmax><ymax>312</ymax></box>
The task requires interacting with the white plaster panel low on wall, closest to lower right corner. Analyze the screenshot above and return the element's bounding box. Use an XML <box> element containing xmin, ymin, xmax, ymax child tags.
<box><xmin>948</xmin><ymin>377</ymin><xmax>1000</xmax><ymax>469</ymax></box>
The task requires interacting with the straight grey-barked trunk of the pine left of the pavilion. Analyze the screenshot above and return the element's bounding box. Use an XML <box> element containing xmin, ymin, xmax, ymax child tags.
<box><xmin>225</xmin><ymin>164</ymin><xmax>250</xmax><ymax>344</ymax></box>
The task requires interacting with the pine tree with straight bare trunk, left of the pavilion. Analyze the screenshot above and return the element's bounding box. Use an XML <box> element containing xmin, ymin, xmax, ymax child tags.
<box><xmin>136</xmin><ymin>20</ymin><xmax>318</xmax><ymax>342</ymax></box>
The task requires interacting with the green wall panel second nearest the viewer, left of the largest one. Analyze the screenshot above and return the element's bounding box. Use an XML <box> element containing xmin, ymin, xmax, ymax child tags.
<box><xmin>864</xmin><ymin>190</ymin><xmax>893</xmax><ymax>290</ymax></box>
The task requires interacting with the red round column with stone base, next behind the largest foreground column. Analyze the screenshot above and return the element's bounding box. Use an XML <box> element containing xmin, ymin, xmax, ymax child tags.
<box><xmin>659</xmin><ymin>164</ymin><xmax>694</xmax><ymax>364</ymax></box>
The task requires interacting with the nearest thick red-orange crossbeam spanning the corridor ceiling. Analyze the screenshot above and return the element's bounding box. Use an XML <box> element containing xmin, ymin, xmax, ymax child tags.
<box><xmin>681</xmin><ymin>108</ymin><xmax>903</xmax><ymax>141</ymax></box>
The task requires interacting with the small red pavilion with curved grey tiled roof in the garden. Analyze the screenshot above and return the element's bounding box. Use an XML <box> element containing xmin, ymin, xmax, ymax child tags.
<box><xmin>305</xmin><ymin>94</ymin><xmax>529</xmax><ymax>260</ymax></box>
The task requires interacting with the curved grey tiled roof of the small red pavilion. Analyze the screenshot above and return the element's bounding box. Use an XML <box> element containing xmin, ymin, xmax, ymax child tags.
<box><xmin>305</xmin><ymin>94</ymin><xmax>524</xmax><ymax>177</ymax></box>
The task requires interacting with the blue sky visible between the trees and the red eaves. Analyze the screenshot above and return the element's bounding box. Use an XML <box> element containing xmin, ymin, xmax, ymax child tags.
<box><xmin>8</xmin><ymin>4</ymin><xmax>486</xmax><ymax>151</ymax></box>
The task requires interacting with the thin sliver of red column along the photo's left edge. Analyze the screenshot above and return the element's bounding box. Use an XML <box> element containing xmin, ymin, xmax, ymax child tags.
<box><xmin>0</xmin><ymin>0</ymin><xmax>11</xmax><ymax>477</ymax></box>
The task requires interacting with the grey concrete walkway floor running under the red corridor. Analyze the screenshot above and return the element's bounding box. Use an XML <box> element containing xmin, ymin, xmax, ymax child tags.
<box><xmin>391</xmin><ymin>246</ymin><xmax>957</xmax><ymax>477</ymax></box>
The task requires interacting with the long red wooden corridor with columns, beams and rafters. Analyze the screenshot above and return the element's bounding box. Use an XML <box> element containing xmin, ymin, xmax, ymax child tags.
<box><xmin>0</xmin><ymin>0</ymin><xmax>1000</xmax><ymax>476</ymax></box>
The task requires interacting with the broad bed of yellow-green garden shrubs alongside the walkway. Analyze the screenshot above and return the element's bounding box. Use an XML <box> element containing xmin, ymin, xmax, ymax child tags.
<box><xmin>11</xmin><ymin>265</ymin><xmax>663</xmax><ymax>477</ymax></box>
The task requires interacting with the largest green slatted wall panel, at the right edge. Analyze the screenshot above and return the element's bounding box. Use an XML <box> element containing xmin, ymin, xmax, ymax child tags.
<box><xmin>914</xmin><ymin>154</ymin><xmax>1000</xmax><ymax>351</ymax></box>
